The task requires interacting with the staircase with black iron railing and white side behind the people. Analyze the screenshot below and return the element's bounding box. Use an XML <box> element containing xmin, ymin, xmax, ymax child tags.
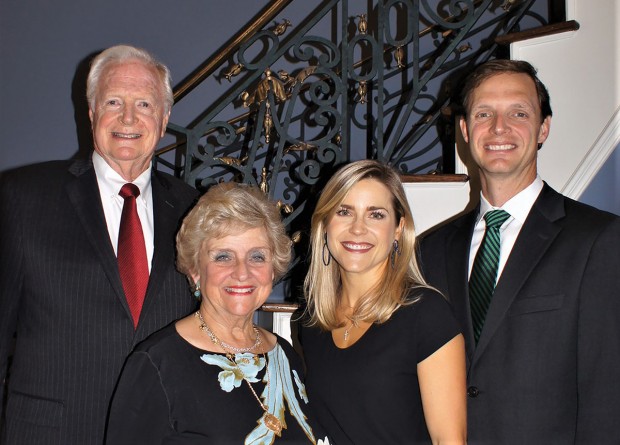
<box><xmin>156</xmin><ymin>0</ymin><xmax>620</xmax><ymax>336</ymax></box>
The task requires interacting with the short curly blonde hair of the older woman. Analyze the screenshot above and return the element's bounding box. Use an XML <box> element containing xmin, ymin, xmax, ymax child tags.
<box><xmin>176</xmin><ymin>182</ymin><xmax>291</xmax><ymax>284</ymax></box>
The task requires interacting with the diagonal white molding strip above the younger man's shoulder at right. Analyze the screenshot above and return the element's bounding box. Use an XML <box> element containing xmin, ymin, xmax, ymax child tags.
<box><xmin>562</xmin><ymin>107</ymin><xmax>620</xmax><ymax>199</ymax></box>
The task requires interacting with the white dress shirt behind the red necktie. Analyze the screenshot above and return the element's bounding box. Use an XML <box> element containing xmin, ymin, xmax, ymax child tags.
<box><xmin>93</xmin><ymin>152</ymin><xmax>154</xmax><ymax>272</ymax></box>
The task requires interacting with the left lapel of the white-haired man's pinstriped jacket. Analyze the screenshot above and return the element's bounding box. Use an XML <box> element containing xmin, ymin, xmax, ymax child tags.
<box><xmin>65</xmin><ymin>161</ymin><xmax>130</xmax><ymax>308</ymax></box>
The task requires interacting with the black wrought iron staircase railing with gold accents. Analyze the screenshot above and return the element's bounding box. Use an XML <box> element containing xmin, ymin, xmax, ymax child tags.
<box><xmin>156</xmin><ymin>0</ymin><xmax>546</xmax><ymax>300</ymax></box>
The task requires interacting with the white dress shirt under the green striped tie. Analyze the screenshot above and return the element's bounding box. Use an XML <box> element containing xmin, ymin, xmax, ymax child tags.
<box><xmin>467</xmin><ymin>175</ymin><xmax>544</xmax><ymax>283</ymax></box>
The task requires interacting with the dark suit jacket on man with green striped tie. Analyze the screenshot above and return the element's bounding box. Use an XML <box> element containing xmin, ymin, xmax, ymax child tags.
<box><xmin>421</xmin><ymin>185</ymin><xmax>620</xmax><ymax>445</ymax></box>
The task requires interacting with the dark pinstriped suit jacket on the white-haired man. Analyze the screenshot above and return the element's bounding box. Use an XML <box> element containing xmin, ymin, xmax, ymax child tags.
<box><xmin>0</xmin><ymin>161</ymin><xmax>196</xmax><ymax>445</ymax></box>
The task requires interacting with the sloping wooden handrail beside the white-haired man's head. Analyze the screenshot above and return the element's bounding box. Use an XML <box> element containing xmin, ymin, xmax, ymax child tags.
<box><xmin>173</xmin><ymin>0</ymin><xmax>293</xmax><ymax>103</ymax></box>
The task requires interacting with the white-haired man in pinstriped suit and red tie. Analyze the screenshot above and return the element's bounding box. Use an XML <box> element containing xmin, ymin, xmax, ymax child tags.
<box><xmin>0</xmin><ymin>46</ymin><xmax>196</xmax><ymax>445</ymax></box>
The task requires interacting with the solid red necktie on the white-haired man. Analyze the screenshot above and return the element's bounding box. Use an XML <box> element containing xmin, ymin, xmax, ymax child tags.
<box><xmin>116</xmin><ymin>184</ymin><xmax>149</xmax><ymax>328</ymax></box>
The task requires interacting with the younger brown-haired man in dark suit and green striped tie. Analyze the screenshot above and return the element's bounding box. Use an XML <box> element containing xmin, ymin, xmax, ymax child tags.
<box><xmin>421</xmin><ymin>60</ymin><xmax>620</xmax><ymax>445</ymax></box>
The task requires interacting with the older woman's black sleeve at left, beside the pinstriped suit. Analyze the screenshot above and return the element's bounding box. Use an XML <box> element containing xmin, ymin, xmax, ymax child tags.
<box><xmin>106</xmin><ymin>352</ymin><xmax>172</xmax><ymax>445</ymax></box>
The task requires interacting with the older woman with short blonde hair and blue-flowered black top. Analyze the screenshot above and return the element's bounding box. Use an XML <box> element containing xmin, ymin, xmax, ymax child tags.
<box><xmin>107</xmin><ymin>183</ymin><xmax>328</xmax><ymax>445</ymax></box>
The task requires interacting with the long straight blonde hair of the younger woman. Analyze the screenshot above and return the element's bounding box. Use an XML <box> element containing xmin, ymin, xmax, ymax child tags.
<box><xmin>304</xmin><ymin>160</ymin><xmax>428</xmax><ymax>330</ymax></box>
